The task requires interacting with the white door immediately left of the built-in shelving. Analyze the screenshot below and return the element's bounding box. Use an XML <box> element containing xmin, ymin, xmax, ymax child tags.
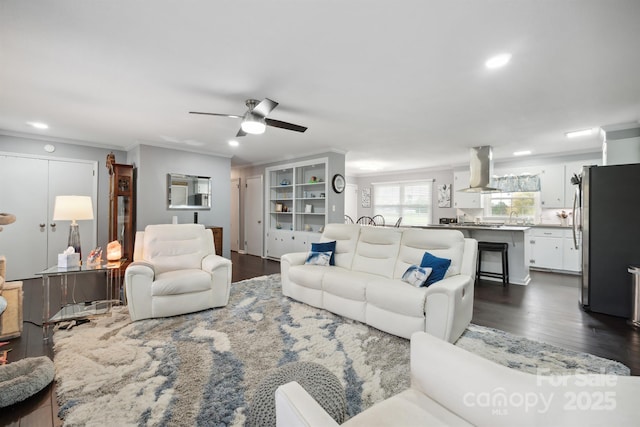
<box><xmin>244</xmin><ymin>176</ymin><xmax>264</xmax><ymax>256</ymax></box>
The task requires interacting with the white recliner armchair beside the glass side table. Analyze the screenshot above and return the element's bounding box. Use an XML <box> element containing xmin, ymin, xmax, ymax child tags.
<box><xmin>124</xmin><ymin>224</ymin><xmax>231</xmax><ymax>321</ymax></box>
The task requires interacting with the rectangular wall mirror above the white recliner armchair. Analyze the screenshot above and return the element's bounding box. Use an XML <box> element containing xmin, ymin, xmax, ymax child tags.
<box><xmin>167</xmin><ymin>173</ymin><xmax>211</xmax><ymax>209</ymax></box>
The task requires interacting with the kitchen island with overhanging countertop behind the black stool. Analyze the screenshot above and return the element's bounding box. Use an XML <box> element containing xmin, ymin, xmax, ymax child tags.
<box><xmin>420</xmin><ymin>224</ymin><xmax>531</xmax><ymax>285</ymax></box>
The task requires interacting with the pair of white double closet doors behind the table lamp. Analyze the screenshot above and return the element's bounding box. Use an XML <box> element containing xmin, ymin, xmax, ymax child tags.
<box><xmin>0</xmin><ymin>156</ymin><xmax>97</xmax><ymax>280</ymax></box>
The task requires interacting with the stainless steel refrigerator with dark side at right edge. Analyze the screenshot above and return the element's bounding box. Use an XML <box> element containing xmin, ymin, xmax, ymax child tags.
<box><xmin>572</xmin><ymin>164</ymin><xmax>640</xmax><ymax>318</ymax></box>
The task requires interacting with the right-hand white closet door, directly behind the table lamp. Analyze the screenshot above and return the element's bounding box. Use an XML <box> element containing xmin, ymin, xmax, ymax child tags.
<box><xmin>44</xmin><ymin>160</ymin><xmax>97</xmax><ymax>268</ymax></box>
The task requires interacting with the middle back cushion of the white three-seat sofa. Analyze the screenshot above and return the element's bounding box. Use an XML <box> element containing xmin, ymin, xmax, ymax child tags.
<box><xmin>352</xmin><ymin>227</ymin><xmax>400</xmax><ymax>278</ymax></box>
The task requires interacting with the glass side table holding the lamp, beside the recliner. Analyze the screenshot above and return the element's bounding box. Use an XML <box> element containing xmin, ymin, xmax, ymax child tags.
<box><xmin>36</xmin><ymin>260</ymin><xmax>125</xmax><ymax>341</ymax></box>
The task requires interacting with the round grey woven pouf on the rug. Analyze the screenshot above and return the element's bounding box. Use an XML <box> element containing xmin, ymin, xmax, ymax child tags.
<box><xmin>248</xmin><ymin>362</ymin><xmax>347</xmax><ymax>427</ymax></box>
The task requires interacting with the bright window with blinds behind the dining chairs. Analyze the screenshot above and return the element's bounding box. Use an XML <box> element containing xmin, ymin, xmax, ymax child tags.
<box><xmin>373</xmin><ymin>179</ymin><xmax>433</xmax><ymax>225</ymax></box>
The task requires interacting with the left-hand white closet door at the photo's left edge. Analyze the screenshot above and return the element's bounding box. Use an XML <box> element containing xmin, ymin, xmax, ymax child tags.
<box><xmin>0</xmin><ymin>156</ymin><xmax>49</xmax><ymax>281</ymax></box>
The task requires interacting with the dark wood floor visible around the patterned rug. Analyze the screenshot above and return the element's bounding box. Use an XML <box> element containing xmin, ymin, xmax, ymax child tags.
<box><xmin>0</xmin><ymin>252</ymin><xmax>640</xmax><ymax>427</ymax></box>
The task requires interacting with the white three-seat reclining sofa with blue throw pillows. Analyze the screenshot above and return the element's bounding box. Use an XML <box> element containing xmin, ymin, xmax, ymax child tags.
<box><xmin>280</xmin><ymin>224</ymin><xmax>478</xmax><ymax>342</ymax></box>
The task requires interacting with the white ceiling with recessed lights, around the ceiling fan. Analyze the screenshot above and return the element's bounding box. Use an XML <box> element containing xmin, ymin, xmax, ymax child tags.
<box><xmin>0</xmin><ymin>0</ymin><xmax>640</xmax><ymax>175</ymax></box>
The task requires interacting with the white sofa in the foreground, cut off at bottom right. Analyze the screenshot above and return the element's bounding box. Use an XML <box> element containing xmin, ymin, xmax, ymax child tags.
<box><xmin>275</xmin><ymin>332</ymin><xmax>640</xmax><ymax>427</ymax></box>
